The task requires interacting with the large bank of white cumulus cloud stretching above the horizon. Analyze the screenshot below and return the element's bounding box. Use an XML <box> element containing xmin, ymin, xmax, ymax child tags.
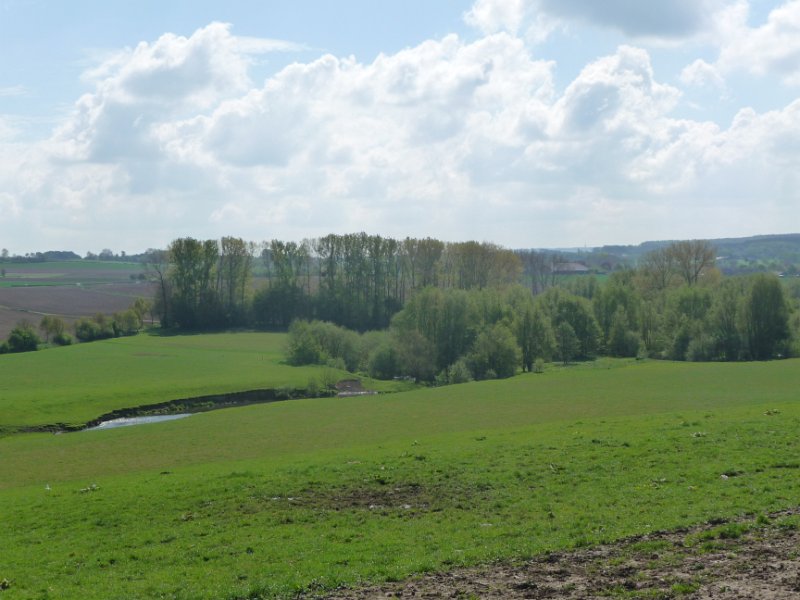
<box><xmin>0</xmin><ymin>17</ymin><xmax>800</xmax><ymax>250</ymax></box>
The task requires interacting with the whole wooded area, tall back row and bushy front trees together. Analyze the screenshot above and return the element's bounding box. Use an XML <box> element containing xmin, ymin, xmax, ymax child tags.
<box><xmin>131</xmin><ymin>233</ymin><xmax>800</xmax><ymax>381</ymax></box>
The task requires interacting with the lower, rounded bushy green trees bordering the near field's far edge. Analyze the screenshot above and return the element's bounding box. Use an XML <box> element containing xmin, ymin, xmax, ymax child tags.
<box><xmin>287</xmin><ymin>270</ymin><xmax>800</xmax><ymax>383</ymax></box>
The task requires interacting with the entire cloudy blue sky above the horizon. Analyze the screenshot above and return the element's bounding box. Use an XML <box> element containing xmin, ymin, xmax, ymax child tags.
<box><xmin>0</xmin><ymin>0</ymin><xmax>800</xmax><ymax>254</ymax></box>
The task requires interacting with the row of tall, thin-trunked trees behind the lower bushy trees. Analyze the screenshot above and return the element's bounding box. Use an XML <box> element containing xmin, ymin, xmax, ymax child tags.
<box><xmin>146</xmin><ymin>233</ymin><xmax>523</xmax><ymax>331</ymax></box>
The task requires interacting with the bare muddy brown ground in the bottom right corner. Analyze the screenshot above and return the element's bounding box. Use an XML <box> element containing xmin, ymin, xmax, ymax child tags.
<box><xmin>317</xmin><ymin>509</ymin><xmax>800</xmax><ymax>600</ymax></box>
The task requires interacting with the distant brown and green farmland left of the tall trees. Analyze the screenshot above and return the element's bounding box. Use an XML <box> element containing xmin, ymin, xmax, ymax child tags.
<box><xmin>0</xmin><ymin>261</ymin><xmax>154</xmax><ymax>340</ymax></box>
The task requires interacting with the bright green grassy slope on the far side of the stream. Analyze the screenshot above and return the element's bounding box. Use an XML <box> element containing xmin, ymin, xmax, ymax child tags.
<box><xmin>0</xmin><ymin>333</ymin><xmax>352</xmax><ymax>428</ymax></box>
